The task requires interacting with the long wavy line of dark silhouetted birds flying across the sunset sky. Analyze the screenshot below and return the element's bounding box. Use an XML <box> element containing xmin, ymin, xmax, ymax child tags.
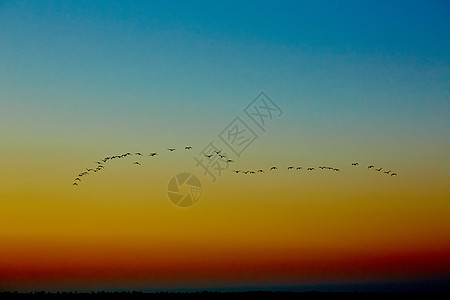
<box><xmin>72</xmin><ymin>146</ymin><xmax>397</xmax><ymax>186</ymax></box>
